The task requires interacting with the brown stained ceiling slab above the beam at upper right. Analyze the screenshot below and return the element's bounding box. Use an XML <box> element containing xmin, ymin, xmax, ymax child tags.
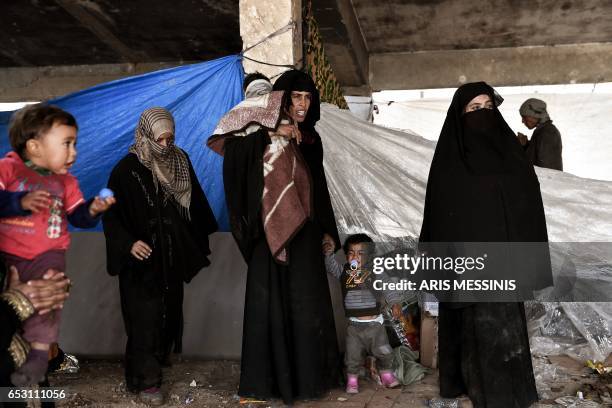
<box><xmin>352</xmin><ymin>0</ymin><xmax>612</xmax><ymax>53</ymax></box>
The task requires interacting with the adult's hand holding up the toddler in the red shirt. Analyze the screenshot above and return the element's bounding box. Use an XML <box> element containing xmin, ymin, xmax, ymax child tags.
<box><xmin>8</xmin><ymin>266</ymin><xmax>70</xmax><ymax>315</ymax></box>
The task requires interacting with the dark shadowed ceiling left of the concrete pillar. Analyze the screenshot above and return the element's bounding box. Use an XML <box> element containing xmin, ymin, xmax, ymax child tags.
<box><xmin>0</xmin><ymin>0</ymin><xmax>242</xmax><ymax>67</ymax></box>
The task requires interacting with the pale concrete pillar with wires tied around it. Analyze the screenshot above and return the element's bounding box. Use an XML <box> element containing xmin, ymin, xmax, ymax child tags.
<box><xmin>239</xmin><ymin>0</ymin><xmax>303</xmax><ymax>78</ymax></box>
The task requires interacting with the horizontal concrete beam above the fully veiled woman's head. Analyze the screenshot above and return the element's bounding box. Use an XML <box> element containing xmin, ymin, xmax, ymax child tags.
<box><xmin>370</xmin><ymin>43</ymin><xmax>612</xmax><ymax>90</ymax></box>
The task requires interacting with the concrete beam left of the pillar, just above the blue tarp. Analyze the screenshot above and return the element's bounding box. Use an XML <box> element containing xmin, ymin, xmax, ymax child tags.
<box><xmin>0</xmin><ymin>62</ymin><xmax>182</xmax><ymax>102</ymax></box>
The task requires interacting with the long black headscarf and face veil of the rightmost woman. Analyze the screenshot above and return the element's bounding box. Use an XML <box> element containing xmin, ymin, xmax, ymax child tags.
<box><xmin>420</xmin><ymin>82</ymin><xmax>551</xmax><ymax>298</ymax></box>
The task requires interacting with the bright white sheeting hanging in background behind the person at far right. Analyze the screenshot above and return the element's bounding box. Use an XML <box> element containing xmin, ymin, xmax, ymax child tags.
<box><xmin>374</xmin><ymin>87</ymin><xmax>612</xmax><ymax>180</ymax></box>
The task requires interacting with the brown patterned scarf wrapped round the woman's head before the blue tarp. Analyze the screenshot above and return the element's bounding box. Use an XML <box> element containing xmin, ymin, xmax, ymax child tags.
<box><xmin>130</xmin><ymin>108</ymin><xmax>191</xmax><ymax>219</ymax></box>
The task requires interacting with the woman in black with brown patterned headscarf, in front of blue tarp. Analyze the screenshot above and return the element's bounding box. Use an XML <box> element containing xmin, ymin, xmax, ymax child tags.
<box><xmin>103</xmin><ymin>108</ymin><xmax>217</xmax><ymax>404</ymax></box>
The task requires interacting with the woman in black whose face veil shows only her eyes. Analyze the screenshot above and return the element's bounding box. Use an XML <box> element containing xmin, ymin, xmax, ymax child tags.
<box><xmin>420</xmin><ymin>82</ymin><xmax>551</xmax><ymax>408</ymax></box>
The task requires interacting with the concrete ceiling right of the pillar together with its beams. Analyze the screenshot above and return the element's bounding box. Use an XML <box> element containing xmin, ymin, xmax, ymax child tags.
<box><xmin>312</xmin><ymin>0</ymin><xmax>612</xmax><ymax>94</ymax></box>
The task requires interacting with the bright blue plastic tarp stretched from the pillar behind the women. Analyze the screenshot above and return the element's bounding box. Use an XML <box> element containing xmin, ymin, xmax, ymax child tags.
<box><xmin>0</xmin><ymin>55</ymin><xmax>244</xmax><ymax>231</ymax></box>
